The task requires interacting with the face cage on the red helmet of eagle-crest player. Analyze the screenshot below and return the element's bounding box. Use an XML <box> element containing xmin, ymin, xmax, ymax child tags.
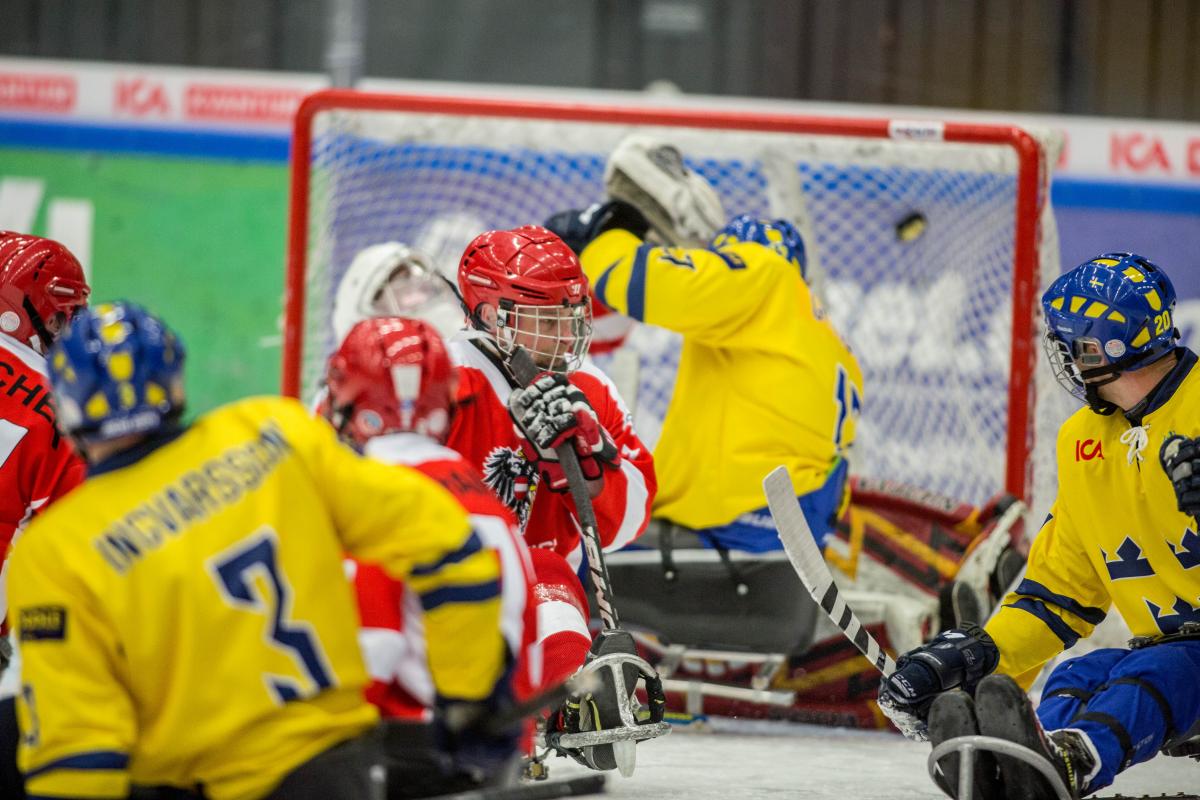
<box><xmin>494</xmin><ymin>299</ymin><xmax>592</xmax><ymax>374</ymax></box>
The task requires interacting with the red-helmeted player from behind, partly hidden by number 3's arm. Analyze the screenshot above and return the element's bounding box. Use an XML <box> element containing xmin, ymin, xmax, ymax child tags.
<box><xmin>325</xmin><ymin>317</ymin><xmax>541</xmax><ymax>796</ymax></box>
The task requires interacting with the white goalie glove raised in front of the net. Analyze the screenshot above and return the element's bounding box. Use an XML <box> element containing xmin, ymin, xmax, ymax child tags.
<box><xmin>604</xmin><ymin>133</ymin><xmax>725</xmax><ymax>247</ymax></box>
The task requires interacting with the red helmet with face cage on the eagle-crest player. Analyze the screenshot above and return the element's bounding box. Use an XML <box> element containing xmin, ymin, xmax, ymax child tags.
<box><xmin>458</xmin><ymin>225</ymin><xmax>592</xmax><ymax>372</ymax></box>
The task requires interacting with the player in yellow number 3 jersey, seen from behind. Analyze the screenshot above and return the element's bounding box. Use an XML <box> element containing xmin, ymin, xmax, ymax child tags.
<box><xmin>10</xmin><ymin>303</ymin><xmax>509</xmax><ymax>800</ymax></box>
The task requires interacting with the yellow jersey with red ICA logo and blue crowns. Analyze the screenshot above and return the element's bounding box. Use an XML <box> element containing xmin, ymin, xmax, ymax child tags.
<box><xmin>986</xmin><ymin>348</ymin><xmax>1200</xmax><ymax>686</ymax></box>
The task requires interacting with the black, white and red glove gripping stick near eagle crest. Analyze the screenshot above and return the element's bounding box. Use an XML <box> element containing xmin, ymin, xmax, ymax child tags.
<box><xmin>509</xmin><ymin>372</ymin><xmax>620</xmax><ymax>492</ymax></box>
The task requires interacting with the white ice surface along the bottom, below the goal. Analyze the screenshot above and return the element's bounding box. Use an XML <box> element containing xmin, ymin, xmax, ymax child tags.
<box><xmin>548</xmin><ymin>722</ymin><xmax>1200</xmax><ymax>800</ymax></box>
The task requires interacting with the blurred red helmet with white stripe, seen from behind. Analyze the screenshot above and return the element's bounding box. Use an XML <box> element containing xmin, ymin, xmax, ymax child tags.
<box><xmin>323</xmin><ymin>317</ymin><xmax>455</xmax><ymax>447</ymax></box>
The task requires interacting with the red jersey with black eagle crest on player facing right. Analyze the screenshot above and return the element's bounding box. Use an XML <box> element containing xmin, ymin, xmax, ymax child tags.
<box><xmin>446</xmin><ymin>332</ymin><xmax>658</xmax><ymax>569</ymax></box>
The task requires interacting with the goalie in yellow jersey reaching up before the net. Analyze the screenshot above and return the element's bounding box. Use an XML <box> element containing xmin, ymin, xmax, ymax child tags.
<box><xmin>547</xmin><ymin>136</ymin><xmax>863</xmax><ymax>552</ymax></box>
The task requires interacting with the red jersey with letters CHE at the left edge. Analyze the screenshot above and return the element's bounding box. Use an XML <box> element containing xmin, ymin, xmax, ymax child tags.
<box><xmin>0</xmin><ymin>333</ymin><xmax>86</xmax><ymax>618</ymax></box>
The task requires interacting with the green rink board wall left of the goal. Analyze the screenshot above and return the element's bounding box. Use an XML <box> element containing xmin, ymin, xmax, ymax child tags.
<box><xmin>0</xmin><ymin>148</ymin><xmax>288</xmax><ymax>416</ymax></box>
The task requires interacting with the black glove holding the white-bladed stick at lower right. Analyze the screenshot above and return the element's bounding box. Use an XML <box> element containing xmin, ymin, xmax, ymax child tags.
<box><xmin>878</xmin><ymin>625</ymin><xmax>1000</xmax><ymax>741</ymax></box>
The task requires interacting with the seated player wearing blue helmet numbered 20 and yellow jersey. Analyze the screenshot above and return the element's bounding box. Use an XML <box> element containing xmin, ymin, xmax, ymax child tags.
<box><xmin>880</xmin><ymin>253</ymin><xmax>1200</xmax><ymax>800</ymax></box>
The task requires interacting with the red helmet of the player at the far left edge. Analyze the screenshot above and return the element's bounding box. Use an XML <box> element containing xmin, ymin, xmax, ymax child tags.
<box><xmin>0</xmin><ymin>230</ymin><xmax>91</xmax><ymax>353</ymax></box>
